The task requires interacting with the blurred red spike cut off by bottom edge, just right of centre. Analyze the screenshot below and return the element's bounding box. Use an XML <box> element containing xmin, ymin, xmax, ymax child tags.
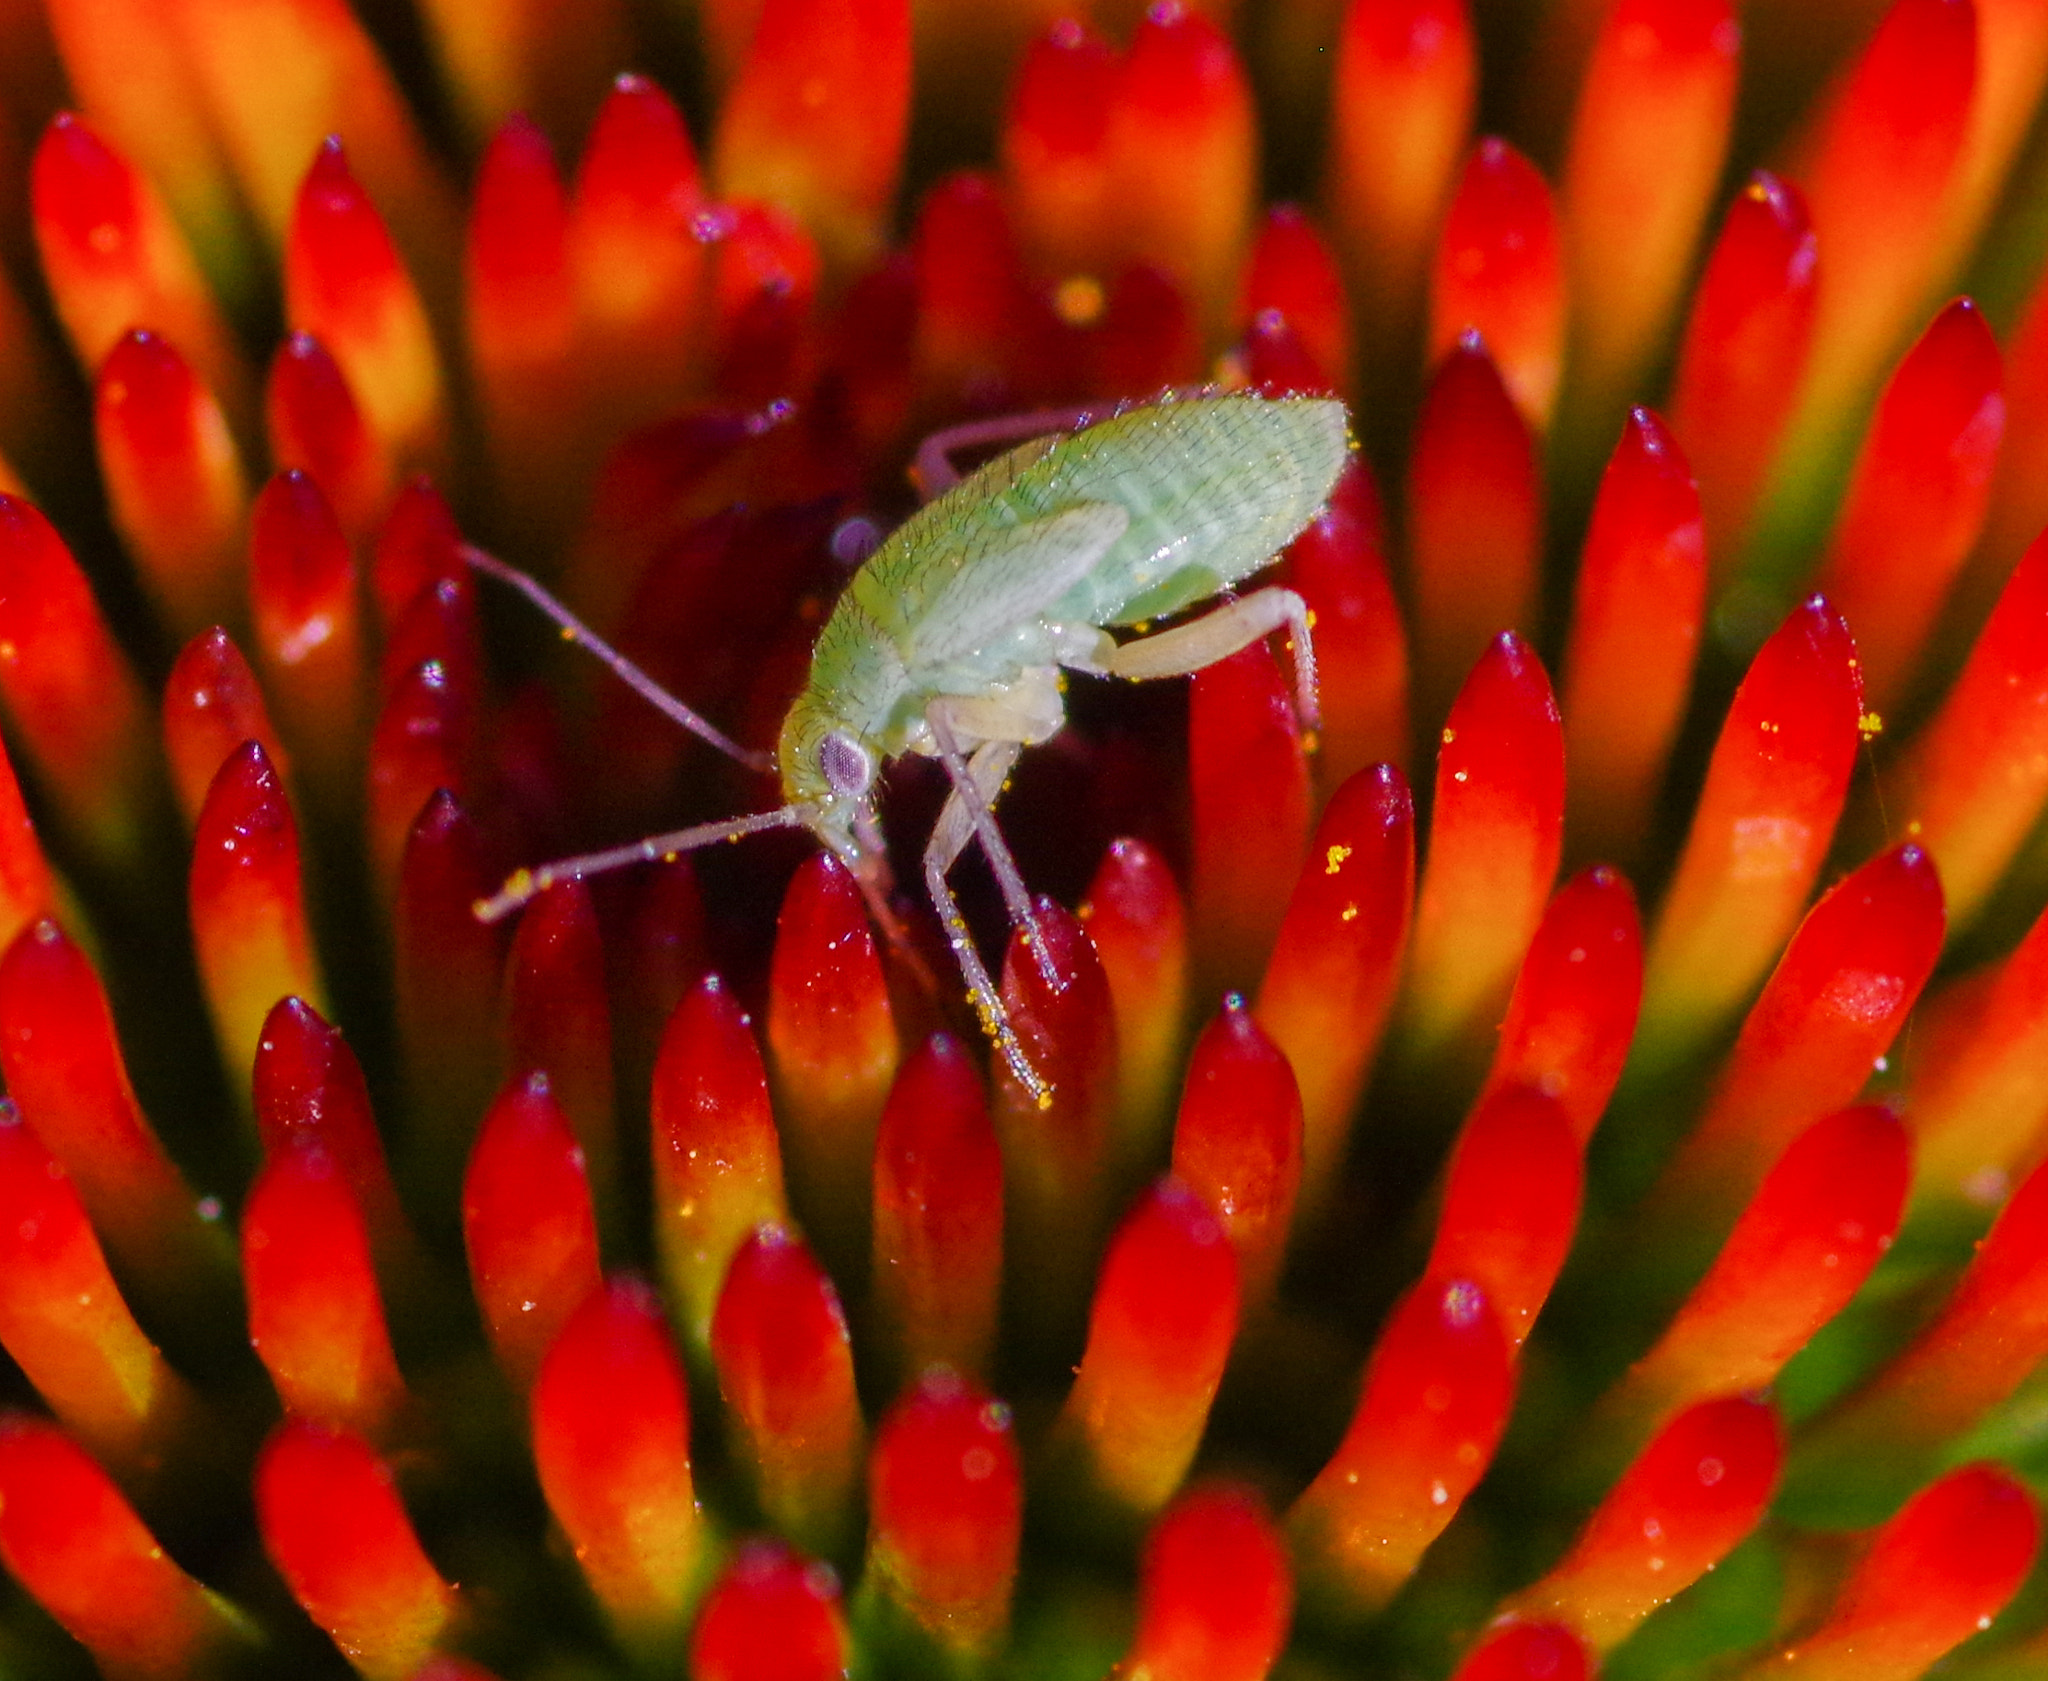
<box><xmin>1118</xmin><ymin>1482</ymin><xmax>1294</xmax><ymax>1681</ymax></box>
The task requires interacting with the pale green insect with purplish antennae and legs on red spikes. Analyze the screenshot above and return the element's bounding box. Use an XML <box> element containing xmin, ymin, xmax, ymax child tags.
<box><xmin>469</xmin><ymin>393</ymin><xmax>1350</xmax><ymax>1104</ymax></box>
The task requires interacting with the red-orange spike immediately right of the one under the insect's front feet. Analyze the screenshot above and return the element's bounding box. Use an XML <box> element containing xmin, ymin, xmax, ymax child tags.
<box><xmin>1079</xmin><ymin>837</ymin><xmax>1188</xmax><ymax>1159</ymax></box>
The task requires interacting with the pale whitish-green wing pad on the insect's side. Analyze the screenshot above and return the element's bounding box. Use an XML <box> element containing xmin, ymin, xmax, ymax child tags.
<box><xmin>915</xmin><ymin>502</ymin><xmax>1130</xmax><ymax>663</ymax></box>
